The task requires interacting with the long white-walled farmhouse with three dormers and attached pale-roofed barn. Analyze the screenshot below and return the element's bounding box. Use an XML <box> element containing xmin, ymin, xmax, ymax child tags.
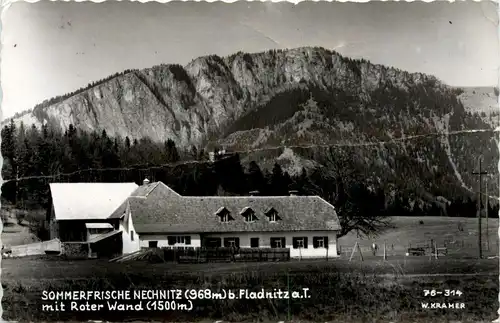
<box><xmin>51</xmin><ymin>180</ymin><xmax>340</xmax><ymax>258</ymax></box>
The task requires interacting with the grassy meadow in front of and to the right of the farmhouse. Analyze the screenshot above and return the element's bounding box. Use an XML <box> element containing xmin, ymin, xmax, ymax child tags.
<box><xmin>2</xmin><ymin>218</ymin><xmax>499</xmax><ymax>322</ymax></box>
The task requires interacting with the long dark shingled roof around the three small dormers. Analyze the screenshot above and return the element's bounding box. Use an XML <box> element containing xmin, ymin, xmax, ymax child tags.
<box><xmin>112</xmin><ymin>183</ymin><xmax>340</xmax><ymax>233</ymax></box>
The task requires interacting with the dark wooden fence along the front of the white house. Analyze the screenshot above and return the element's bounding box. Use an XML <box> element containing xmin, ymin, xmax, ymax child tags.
<box><xmin>152</xmin><ymin>247</ymin><xmax>290</xmax><ymax>263</ymax></box>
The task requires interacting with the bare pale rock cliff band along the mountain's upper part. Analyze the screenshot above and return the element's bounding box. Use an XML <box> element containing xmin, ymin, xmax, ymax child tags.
<box><xmin>7</xmin><ymin>48</ymin><xmax>458</xmax><ymax>146</ymax></box>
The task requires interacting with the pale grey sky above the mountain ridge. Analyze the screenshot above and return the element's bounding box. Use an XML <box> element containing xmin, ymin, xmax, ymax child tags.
<box><xmin>0</xmin><ymin>1</ymin><xmax>500</xmax><ymax>118</ymax></box>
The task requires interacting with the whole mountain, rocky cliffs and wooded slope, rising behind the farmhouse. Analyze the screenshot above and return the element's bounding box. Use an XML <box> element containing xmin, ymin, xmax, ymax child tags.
<box><xmin>5</xmin><ymin>47</ymin><xmax>498</xmax><ymax>201</ymax></box>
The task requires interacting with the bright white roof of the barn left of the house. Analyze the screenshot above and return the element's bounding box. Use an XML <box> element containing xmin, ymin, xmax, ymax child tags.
<box><xmin>49</xmin><ymin>183</ymin><xmax>138</xmax><ymax>220</ymax></box>
